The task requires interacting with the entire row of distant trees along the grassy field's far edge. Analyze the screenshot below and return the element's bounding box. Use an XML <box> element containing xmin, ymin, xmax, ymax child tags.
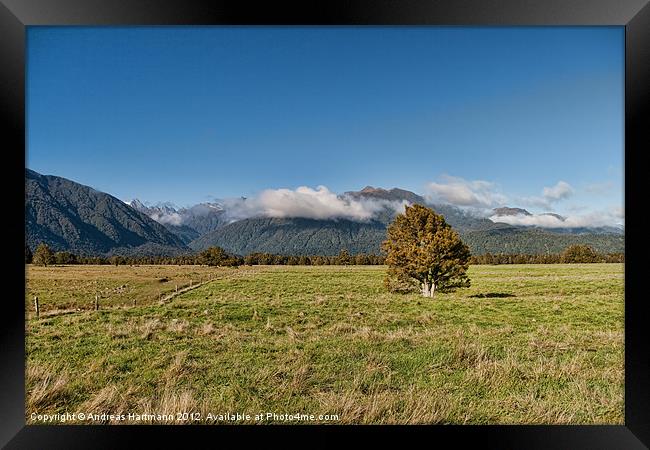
<box><xmin>25</xmin><ymin>244</ymin><xmax>625</xmax><ymax>267</ymax></box>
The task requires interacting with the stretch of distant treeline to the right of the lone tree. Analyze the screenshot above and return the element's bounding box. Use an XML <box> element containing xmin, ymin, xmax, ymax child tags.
<box><xmin>469</xmin><ymin>244</ymin><xmax>625</xmax><ymax>264</ymax></box>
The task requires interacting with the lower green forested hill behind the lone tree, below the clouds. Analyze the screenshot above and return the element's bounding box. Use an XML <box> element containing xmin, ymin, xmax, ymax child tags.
<box><xmin>189</xmin><ymin>218</ymin><xmax>624</xmax><ymax>255</ymax></box>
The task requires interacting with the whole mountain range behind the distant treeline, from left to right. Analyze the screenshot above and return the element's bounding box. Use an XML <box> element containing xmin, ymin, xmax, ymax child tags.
<box><xmin>25</xmin><ymin>169</ymin><xmax>624</xmax><ymax>255</ymax></box>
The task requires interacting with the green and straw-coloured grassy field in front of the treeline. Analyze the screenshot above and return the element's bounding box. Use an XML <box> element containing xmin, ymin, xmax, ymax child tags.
<box><xmin>26</xmin><ymin>264</ymin><xmax>624</xmax><ymax>424</ymax></box>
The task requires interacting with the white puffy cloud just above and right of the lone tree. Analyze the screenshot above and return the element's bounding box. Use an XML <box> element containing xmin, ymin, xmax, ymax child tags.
<box><xmin>425</xmin><ymin>175</ymin><xmax>508</xmax><ymax>208</ymax></box>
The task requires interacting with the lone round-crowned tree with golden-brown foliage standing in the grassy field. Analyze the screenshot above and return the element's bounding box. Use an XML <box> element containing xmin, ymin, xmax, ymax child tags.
<box><xmin>382</xmin><ymin>204</ymin><xmax>471</xmax><ymax>297</ymax></box>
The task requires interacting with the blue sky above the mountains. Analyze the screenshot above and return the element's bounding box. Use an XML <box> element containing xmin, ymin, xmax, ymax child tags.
<box><xmin>26</xmin><ymin>27</ymin><xmax>624</xmax><ymax>225</ymax></box>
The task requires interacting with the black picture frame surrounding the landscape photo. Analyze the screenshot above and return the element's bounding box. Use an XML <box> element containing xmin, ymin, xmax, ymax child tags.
<box><xmin>0</xmin><ymin>0</ymin><xmax>650</xmax><ymax>449</ymax></box>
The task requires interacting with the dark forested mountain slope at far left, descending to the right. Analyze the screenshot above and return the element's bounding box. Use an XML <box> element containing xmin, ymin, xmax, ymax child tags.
<box><xmin>25</xmin><ymin>169</ymin><xmax>187</xmax><ymax>255</ymax></box>
